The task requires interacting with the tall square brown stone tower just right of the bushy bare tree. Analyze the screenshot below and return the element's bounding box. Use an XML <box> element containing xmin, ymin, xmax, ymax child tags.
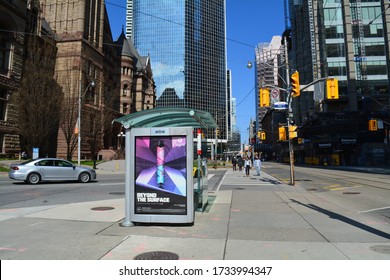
<box><xmin>41</xmin><ymin>0</ymin><xmax>109</xmax><ymax>159</ymax></box>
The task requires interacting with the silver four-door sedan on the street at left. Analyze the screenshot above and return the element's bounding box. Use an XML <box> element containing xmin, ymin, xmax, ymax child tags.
<box><xmin>8</xmin><ymin>158</ymin><xmax>96</xmax><ymax>184</ymax></box>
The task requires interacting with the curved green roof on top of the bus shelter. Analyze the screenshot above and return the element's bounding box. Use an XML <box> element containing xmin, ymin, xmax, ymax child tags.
<box><xmin>114</xmin><ymin>108</ymin><xmax>218</xmax><ymax>128</ymax></box>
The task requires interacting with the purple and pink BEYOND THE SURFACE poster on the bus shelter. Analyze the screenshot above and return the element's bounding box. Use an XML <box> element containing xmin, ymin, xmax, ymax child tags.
<box><xmin>134</xmin><ymin>135</ymin><xmax>187</xmax><ymax>215</ymax></box>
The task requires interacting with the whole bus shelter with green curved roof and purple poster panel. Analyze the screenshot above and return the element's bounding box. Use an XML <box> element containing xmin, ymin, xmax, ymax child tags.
<box><xmin>114</xmin><ymin>108</ymin><xmax>217</xmax><ymax>227</ymax></box>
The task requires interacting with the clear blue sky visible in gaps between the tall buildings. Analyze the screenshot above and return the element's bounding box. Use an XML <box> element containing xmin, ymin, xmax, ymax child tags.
<box><xmin>106</xmin><ymin>0</ymin><xmax>285</xmax><ymax>143</ymax></box>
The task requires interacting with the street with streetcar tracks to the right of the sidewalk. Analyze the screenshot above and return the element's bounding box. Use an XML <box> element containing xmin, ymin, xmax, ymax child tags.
<box><xmin>263</xmin><ymin>163</ymin><xmax>390</xmax><ymax>225</ymax></box>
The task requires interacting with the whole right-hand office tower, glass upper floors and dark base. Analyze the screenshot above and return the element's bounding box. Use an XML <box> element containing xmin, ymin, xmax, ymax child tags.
<box><xmin>289</xmin><ymin>0</ymin><xmax>390</xmax><ymax>166</ymax></box>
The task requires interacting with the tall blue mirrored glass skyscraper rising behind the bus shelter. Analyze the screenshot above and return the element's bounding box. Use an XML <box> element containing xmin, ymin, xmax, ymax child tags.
<box><xmin>126</xmin><ymin>0</ymin><xmax>230</xmax><ymax>139</ymax></box>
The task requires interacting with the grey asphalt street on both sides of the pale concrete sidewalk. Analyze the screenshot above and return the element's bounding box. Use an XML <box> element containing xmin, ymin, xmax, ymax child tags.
<box><xmin>0</xmin><ymin>162</ymin><xmax>390</xmax><ymax>222</ymax></box>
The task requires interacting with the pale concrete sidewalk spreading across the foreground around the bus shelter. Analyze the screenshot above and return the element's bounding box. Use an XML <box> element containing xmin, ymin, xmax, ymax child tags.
<box><xmin>0</xmin><ymin>162</ymin><xmax>390</xmax><ymax>260</ymax></box>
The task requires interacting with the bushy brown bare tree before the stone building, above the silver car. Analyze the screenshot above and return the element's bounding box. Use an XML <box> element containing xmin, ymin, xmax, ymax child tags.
<box><xmin>14</xmin><ymin>35</ymin><xmax>63</xmax><ymax>156</ymax></box>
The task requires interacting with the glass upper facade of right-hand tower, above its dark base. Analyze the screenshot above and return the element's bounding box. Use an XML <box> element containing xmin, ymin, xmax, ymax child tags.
<box><xmin>289</xmin><ymin>0</ymin><xmax>390</xmax><ymax>121</ymax></box>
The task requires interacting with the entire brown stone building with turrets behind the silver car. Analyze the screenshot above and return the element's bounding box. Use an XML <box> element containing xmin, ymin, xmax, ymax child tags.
<box><xmin>0</xmin><ymin>0</ymin><xmax>156</xmax><ymax>159</ymax></box>
